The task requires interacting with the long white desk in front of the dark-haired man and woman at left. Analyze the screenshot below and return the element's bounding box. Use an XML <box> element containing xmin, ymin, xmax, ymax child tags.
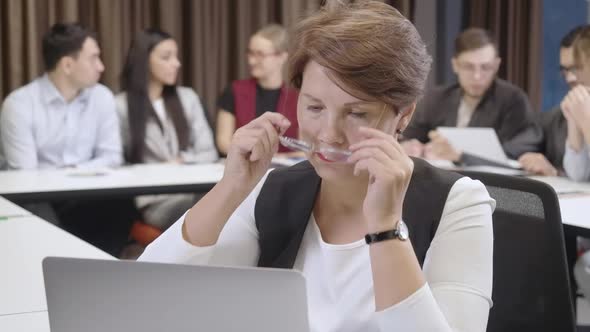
<box><xmin>0</xmin><ymin>164</ymin><xmax>224</xmax><ymax>202</ymax></box>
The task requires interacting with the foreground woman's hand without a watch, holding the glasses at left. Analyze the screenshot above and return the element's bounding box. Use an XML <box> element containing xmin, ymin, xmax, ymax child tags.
<box><xmin>221</xmin><ymin>112</ymin><xmax>291</xmax><ymax>192</ymax></box>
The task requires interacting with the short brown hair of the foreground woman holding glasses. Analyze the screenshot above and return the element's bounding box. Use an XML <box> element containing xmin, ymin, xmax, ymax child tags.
<box><xmin>288</xmin><ymin>1</ymin><xmax>431</xmax><ymax>110</ymax></box>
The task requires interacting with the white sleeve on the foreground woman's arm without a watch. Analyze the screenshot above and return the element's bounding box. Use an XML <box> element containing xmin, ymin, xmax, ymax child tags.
<box><xmin>138</xmin><ymin>176</ymin><xmax>266</xmax><ymax>266</ymax></box>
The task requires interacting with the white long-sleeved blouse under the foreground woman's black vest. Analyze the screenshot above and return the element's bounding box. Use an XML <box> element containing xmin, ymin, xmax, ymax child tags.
<box><xmin>139</xmin><ymin>178</ymin><xmax>495</xmax><ymax>332</ymax></box>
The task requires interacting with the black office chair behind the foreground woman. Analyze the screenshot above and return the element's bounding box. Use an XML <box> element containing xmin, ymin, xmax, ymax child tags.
<box><xmin>460</xmin><ymin>171</ymin><xmax>575</xmax><ymax>332</ymax></box>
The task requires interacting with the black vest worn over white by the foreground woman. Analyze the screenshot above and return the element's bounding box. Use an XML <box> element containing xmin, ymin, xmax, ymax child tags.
<box><xmin>254</xmin><ymin>158</ymin><xmax>462</xmax><ymax>269</ymax></box>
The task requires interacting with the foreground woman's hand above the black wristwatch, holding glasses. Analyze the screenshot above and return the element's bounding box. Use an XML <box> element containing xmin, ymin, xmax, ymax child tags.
<box><xmin>348</xmin><ymin>127</ymin><xmax>414</xmax><ymax>233</ymax></box>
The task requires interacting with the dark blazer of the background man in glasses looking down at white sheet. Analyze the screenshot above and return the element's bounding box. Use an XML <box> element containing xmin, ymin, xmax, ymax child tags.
<box><xmin>404</xmin><ymin>79</ymin><xmax>542</xmax><ymax>159</ymax></box>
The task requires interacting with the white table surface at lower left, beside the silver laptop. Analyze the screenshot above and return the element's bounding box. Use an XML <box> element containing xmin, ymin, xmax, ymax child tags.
<box><xmin>0</xmin><ymin>216</ymin><xmax>115</xmax><ymax>316</ymax></box>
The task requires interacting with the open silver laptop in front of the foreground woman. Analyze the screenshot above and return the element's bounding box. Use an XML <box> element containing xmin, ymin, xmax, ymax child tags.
<box><xmin>43</xmin><ymin>257</ymin><xmax>309</xmax><ymax>332</ymax></box>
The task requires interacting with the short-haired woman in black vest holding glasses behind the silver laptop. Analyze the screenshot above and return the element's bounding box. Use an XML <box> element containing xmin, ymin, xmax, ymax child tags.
<box><xmin>140</xmin><ymin>1</ymin><xmax>494</xmax><ymax>332</ymax></box>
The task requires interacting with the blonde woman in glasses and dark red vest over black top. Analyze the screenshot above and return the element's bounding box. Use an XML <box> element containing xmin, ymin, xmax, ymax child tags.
<box><xmin>216</xmin><ymin>24</ymin><xmax>298</xmax><ymax>155</ymax></box>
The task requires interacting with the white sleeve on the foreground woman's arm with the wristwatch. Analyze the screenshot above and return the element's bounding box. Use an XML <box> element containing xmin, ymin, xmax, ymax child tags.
<box><xmin>373</xmin><ymin>178</ymin><xmax>495</xmax><ymax>332</ymax></box>
